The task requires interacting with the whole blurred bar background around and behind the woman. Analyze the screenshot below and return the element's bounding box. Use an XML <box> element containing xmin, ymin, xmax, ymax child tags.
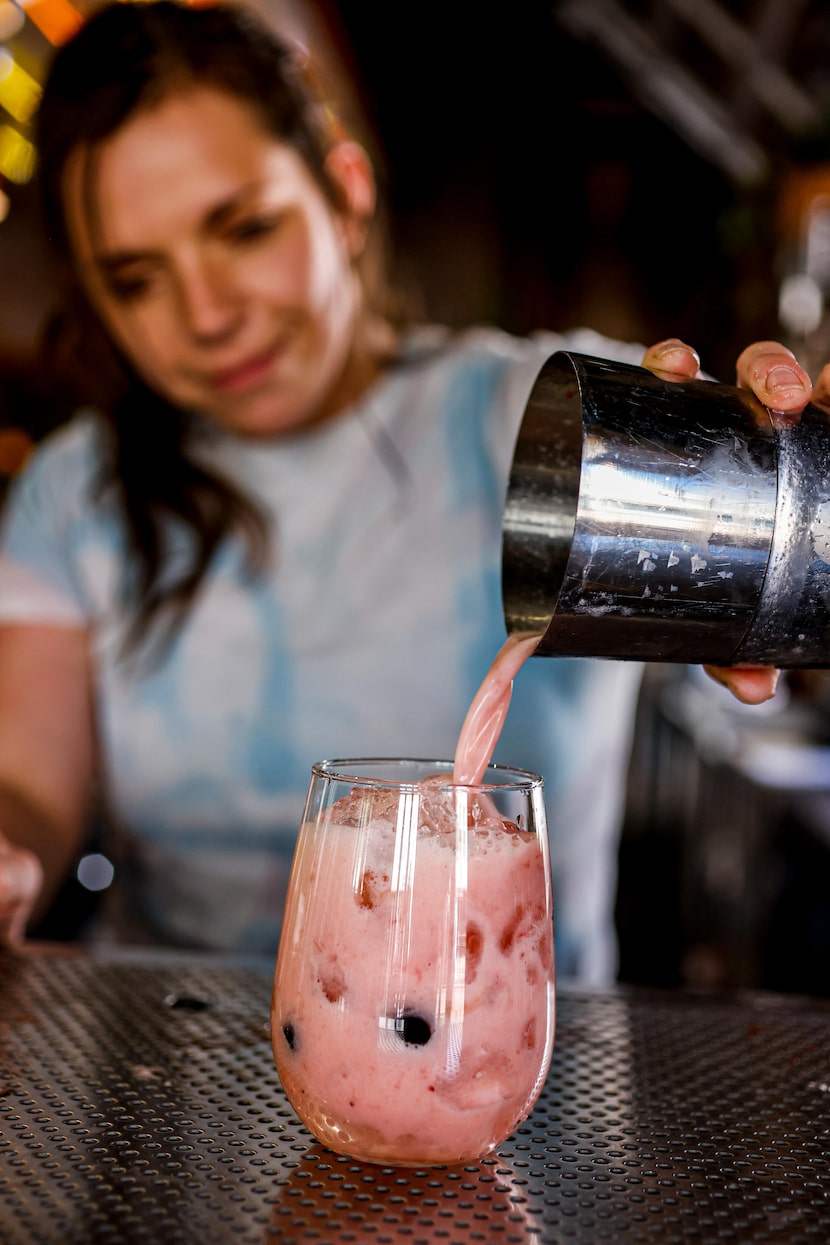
<box><xmin>0</xmin><ymin>0</ymin><xmax>830</xmax><ymax>995</ymax></box>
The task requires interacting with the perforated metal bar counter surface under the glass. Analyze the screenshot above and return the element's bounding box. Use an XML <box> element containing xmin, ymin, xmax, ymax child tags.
<box><xmin>0</xmin><ymin>956</ymin><xmax>830</xmax><ymax>1245</ymax></box>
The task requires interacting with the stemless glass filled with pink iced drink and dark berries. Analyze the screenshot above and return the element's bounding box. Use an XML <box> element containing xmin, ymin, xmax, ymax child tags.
<box><xmin>271</xmin><ymin>758</ymin><xmax>554</xmax><ymax>1165</ymax></box>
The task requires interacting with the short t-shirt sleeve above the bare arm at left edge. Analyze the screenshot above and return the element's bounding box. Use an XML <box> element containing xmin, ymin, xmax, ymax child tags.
<box><xmin>0</xmin><ymin>428</ymin><xmax>98</xmax><ymax>626</ymax></box>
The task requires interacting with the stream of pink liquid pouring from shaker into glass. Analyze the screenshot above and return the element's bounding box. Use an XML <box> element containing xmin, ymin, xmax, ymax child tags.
<box><xmin>453</xmin><ymin>631</ymin><xmax>541</xmax><ymax>787</ymax></box>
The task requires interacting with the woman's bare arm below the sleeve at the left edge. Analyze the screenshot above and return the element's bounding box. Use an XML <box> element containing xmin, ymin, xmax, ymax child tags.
<box><xmin>0</xmin><ymin>624</ymin><xmax>95</xmax><ymax>942</ymax></box>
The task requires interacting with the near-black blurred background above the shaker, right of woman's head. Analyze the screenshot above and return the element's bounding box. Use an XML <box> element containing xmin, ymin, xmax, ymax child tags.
<box><xmin>314</xmin><ymin>0</ymin><xmax>830</xmax><ymax>380</ymax></box>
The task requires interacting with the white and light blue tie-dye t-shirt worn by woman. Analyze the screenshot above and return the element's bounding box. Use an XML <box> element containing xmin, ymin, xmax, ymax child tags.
<box><xmin>0</xmin><ymin>329</ymin><xmax>640</xmax><ymax>981</ymax></box>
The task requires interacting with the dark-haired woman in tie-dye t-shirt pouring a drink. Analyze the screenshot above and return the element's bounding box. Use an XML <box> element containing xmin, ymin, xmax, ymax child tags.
<box><xmin>0</xmin><ymin>0</ymin><xmax>825</xmax><ymax>981</ymax></box>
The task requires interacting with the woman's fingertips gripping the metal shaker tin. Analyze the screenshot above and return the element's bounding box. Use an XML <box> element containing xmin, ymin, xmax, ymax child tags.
<box><xmin>642</xmin><ymin>337</ymin><xmax>830</xmax><ymax>705</ymax></box>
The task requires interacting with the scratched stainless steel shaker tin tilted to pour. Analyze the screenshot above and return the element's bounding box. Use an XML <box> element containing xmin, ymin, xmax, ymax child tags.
<box><xmin>501</xmin><ymin>351</ymin><xmax>830</xmax><ymax>666</ymax></box>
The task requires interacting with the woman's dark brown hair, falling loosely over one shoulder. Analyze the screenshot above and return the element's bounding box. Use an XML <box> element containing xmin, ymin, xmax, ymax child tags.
<box><xmin>35</xmin><ymin>0</ymin><xmax>397</xmax><ymax>650</ymax></box>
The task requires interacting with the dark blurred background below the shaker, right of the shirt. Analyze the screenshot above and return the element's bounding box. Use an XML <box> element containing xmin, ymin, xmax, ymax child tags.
<box><xmin>617</xmin><ymin>666</ymin><xmax>830</xmax><ymax>996</ymax></box>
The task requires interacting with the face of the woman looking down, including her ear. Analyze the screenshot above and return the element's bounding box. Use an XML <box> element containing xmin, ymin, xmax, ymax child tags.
<box><xmin>65</xmin><ymin>87</ymin><xmax>372</xmax><ymax>437</ymax></box>
